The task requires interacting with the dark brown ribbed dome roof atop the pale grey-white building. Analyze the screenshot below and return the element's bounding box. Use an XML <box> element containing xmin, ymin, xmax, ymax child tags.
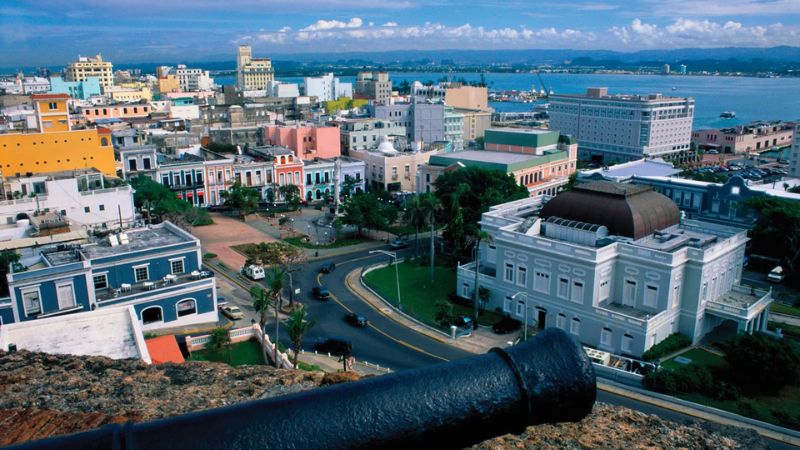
<box><xmin>540</xmin><ymin>181</ymin><xmax>680</xmax><ymax>239</ymax></box>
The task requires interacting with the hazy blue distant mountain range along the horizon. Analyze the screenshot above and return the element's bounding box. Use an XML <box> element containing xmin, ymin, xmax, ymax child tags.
<box><xmin>7</xmin><ymin>46</ymin><xmax>800</xmax><ymax>75</ymax></box>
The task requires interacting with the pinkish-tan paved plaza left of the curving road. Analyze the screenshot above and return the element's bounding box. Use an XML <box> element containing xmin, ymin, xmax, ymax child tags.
<box><xmin>192</xmin><ymin>214</ymin><xmax>275</xmax><ymax>270</ymax></box>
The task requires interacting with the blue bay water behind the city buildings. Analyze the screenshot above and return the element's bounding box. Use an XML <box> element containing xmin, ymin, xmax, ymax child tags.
<box><xmin>216</xmin><ymin>72</ymin><xmax>800</xmax><ymax>128</ymax></box>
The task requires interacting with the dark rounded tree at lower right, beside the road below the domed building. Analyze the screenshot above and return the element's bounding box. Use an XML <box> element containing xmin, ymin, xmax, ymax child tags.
<box><xmin>724</xmin><ymin>333</ymin><xmax>800</xmax><ymax>394</ymax></box>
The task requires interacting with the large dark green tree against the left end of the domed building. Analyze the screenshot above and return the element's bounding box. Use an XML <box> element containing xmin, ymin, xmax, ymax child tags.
<box><xmin>434</xmin><ymin>167</ymin><xmax>529</xmax><ymax>258</ymax></box>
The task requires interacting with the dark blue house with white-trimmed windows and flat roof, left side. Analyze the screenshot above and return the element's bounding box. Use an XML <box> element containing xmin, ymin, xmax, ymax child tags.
<box><xmin>0</xmin><ymin>222</ymin><xmax>218</xmax><ymax>331</ymax></box>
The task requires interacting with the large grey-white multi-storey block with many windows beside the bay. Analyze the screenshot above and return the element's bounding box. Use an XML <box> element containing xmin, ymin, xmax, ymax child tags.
<box><xmin>549</xmin><ymin>88</ymin><xmax>694</xmax><ymax>162</ymax></box>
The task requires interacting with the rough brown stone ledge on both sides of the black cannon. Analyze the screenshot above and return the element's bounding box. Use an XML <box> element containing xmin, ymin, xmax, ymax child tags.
<box><xmin>0</xmin><ymin>351</ymin><xmax>769</xmax><ymax>450</ymax></box>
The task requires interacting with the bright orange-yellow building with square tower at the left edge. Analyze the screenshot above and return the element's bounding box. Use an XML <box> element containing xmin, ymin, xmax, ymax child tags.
<box><xmin>0</xmin><ymin>94</ymin><xmax>116</xmax><ymax>177</ymax></box>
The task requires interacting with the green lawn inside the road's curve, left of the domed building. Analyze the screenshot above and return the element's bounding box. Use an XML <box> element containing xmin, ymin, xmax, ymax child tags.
<box><xmin>364</xmin><ymin>261</ymin><xmax>502</xmax><ymax>327</ymax></box>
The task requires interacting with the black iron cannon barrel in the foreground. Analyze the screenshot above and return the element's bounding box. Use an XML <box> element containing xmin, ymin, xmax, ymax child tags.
<box><xmin>10</xmin><ymin>329</ymin><xmax>596</xmax><ymax>449</ymax></box>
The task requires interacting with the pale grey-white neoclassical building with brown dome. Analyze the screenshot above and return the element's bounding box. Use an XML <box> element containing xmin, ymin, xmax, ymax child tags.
<box><xmin>457</xmin><ymin>182</ymin><xmax>772</xmax><ymax>357</ymax></box>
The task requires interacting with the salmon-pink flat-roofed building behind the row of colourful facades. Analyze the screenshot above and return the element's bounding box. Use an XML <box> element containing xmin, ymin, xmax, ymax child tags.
<box><xmin>264</xmin><ymin>125</ymin><xmax>341</xmax><ymax>160</ymax></box>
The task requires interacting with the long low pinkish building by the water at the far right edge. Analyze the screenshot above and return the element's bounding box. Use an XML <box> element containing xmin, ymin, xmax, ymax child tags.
<box><xmin>692</xmin><ymin>120</ymin><xmax>795</xmax><ymax>154</ymax></box>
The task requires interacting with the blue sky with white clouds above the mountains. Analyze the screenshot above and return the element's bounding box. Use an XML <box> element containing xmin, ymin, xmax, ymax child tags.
<box><xmin>0</xmin><ymin>0</ymin><xmax>800</xmax><ymax>67</ymax></box>
